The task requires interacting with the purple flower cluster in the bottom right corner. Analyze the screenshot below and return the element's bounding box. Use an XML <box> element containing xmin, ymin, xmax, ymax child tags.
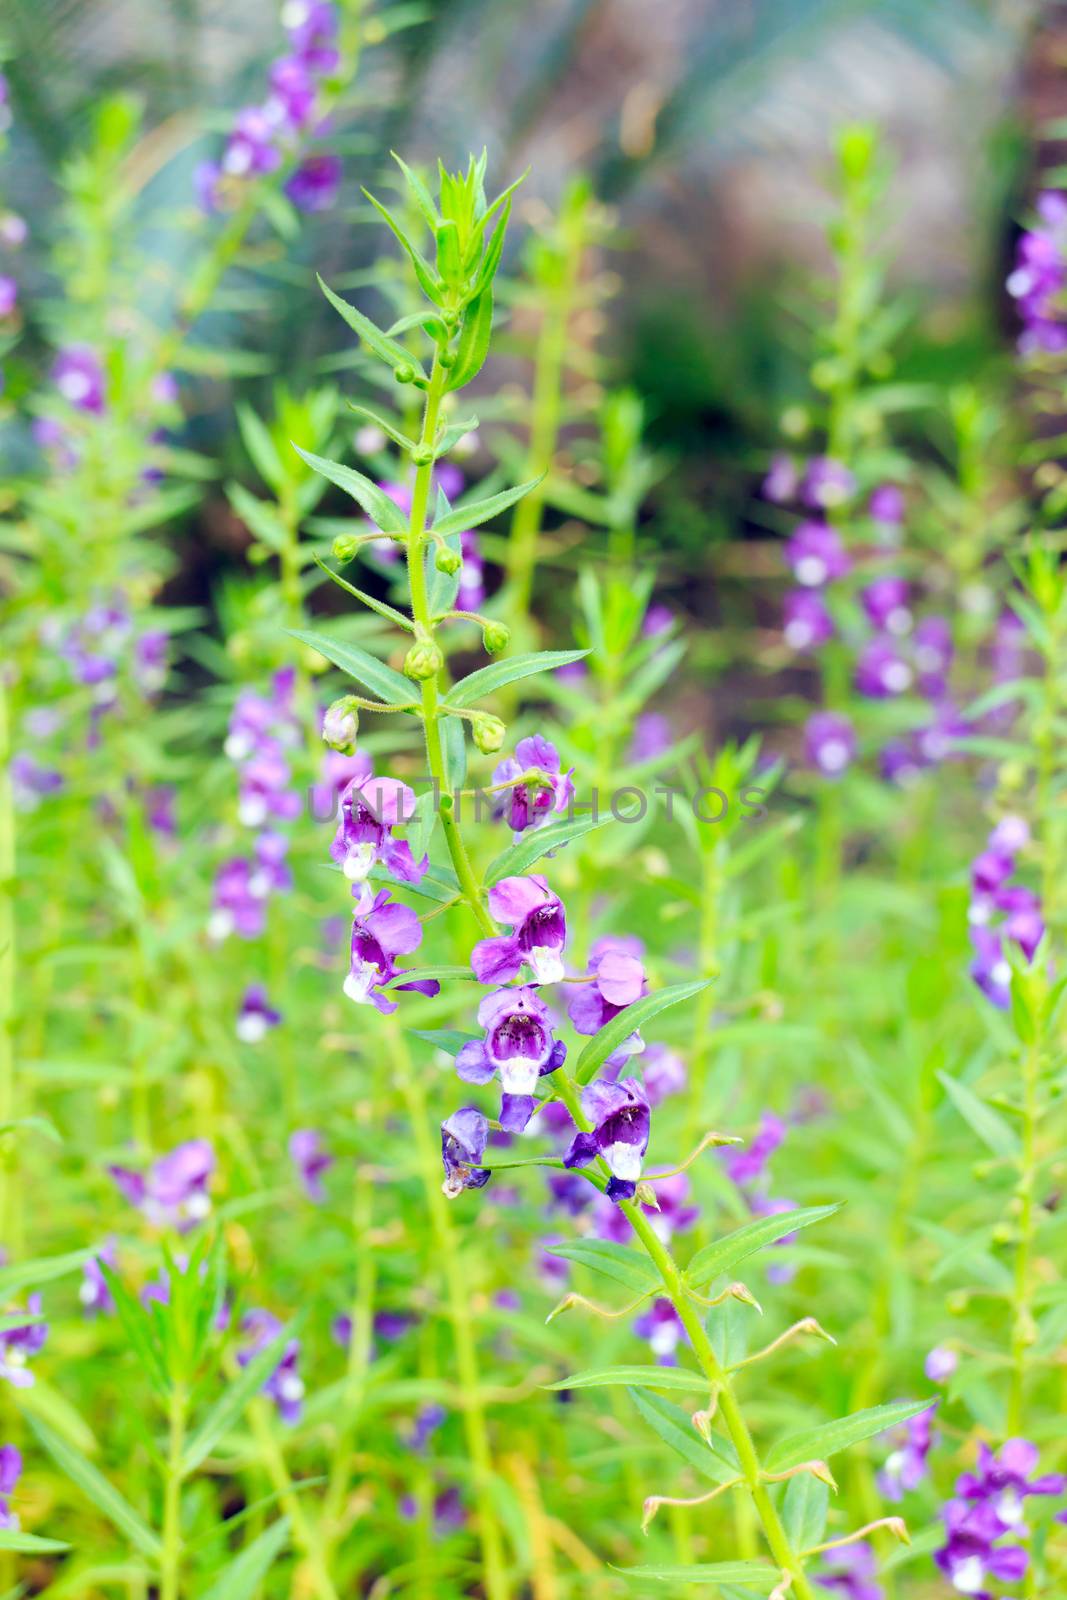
<box><xmin>934</xmin><ymin>1438</ymin><xmax>1067</xmax><ymax>1600</ymax></box>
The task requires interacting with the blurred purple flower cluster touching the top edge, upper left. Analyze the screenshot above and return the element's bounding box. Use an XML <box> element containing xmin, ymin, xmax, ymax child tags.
<box><xmin>194</xmin><ymin>0</ymin><xmax>341</xmax><ymax>211</ymax></box>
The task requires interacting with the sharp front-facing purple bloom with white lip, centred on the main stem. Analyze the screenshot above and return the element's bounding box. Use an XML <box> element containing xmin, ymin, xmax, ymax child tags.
<box><xmin>456</xmin><ymin>987</ymin><xmax>566</xmax><ymax>1133</ymax></box>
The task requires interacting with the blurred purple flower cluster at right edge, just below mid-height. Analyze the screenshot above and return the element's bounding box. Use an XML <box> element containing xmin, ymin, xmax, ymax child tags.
<box><xmin>968</xmin><ymin>816</ymin><xmax>1045</xmax><ymax>1011</ymax></box>
